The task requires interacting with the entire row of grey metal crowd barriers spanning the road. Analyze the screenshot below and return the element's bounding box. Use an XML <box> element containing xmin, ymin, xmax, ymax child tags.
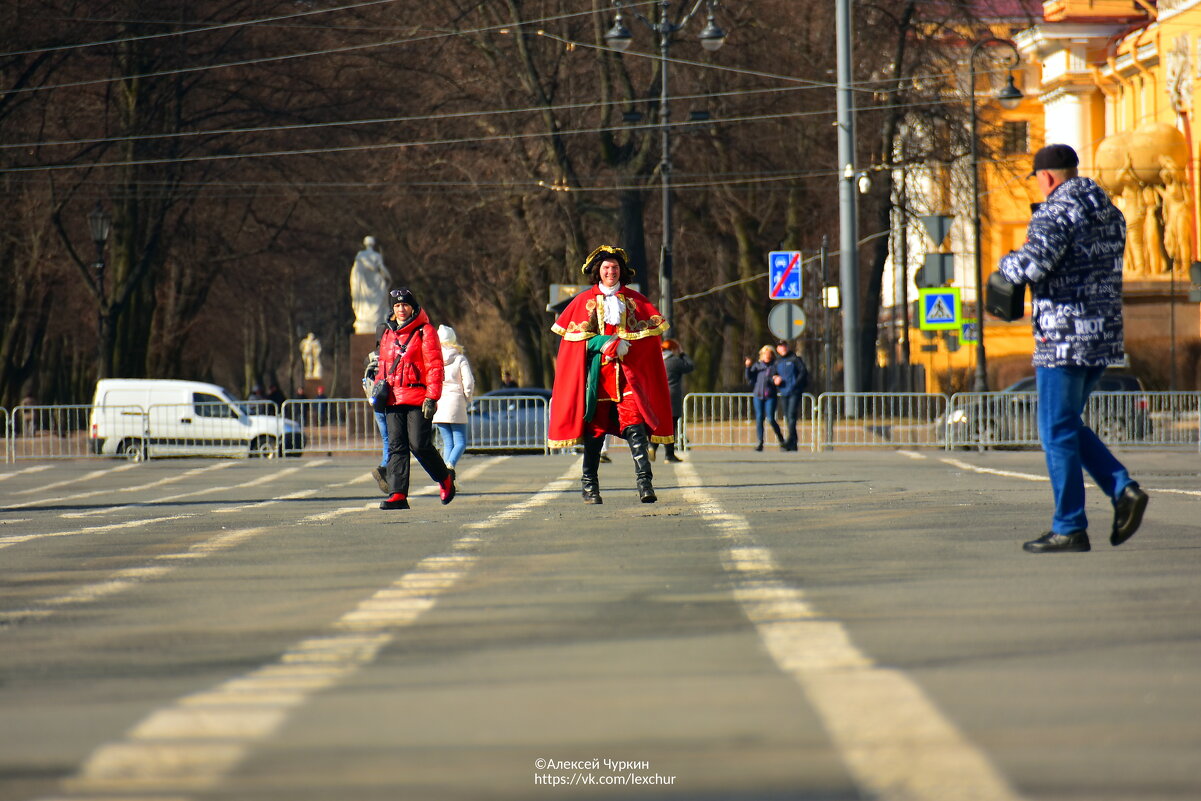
<box><xmin>0</xmin><ymin>391</ymin><xmax>1201</xmax><ymax>462</ymax></box>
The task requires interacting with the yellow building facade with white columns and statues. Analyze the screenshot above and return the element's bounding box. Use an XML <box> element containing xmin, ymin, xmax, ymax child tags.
<box><xmin>910</xmin><ymin>0</ymin><xmax>1201</xmax><ymax>391</ymax></box>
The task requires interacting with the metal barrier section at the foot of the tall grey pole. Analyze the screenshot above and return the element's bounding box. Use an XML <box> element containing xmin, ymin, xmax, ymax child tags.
<box><xmin>814</xmin><ymin>393</ymin><xmax>946</xmax><ymax>448</ymax></box>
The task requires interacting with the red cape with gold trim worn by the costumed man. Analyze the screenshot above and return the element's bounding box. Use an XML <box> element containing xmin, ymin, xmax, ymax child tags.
<box><xmin>546</xmin><ymin>286</ymin><xmax>675</xmax><ymax>448</ymax></box>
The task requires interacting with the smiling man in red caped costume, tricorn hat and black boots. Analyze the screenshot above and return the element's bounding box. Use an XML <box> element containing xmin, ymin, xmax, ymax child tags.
<box><xmin>548</xmin><ymin>245</ymin><xmax>675</xmax><ymax>503</ymax></box>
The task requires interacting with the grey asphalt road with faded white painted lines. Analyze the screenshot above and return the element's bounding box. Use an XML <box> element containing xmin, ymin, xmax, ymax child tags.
<box><xmin>0</xmin><ymin>449</ymin><xmax>1201</xmax><ymax>801</ymax></box>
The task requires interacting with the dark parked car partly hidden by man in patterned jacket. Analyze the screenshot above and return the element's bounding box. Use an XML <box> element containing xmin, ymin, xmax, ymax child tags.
<box><xmin>945</xmin><ymin>372</ymin><xmax>1152</xmax><ymax>448</ymax></box>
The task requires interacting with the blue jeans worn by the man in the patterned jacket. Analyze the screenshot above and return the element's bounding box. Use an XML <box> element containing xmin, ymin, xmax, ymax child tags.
<box><xmin>1034</xmin><ymin>366</ymin><xmax>1130</xmax><ymax>534</ymax></box>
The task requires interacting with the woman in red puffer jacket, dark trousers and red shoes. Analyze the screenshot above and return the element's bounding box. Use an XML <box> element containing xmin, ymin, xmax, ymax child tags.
<box><xmin>377</xmin><ymin>289</ymin><xmax>455</xmax><ymax>509</ymax></box>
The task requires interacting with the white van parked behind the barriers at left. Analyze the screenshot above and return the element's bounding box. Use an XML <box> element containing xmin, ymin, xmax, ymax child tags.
<box><xmin>90</xmin><ymin>378</ymin><xmax>304</xmax><ymax>461</ymax></box>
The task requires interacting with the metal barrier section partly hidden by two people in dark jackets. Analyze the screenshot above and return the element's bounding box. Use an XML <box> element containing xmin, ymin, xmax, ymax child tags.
<box><xmin>680</xmin><ymin>393</ymin><xmax>817</xmax><ymax>450</ymax></box>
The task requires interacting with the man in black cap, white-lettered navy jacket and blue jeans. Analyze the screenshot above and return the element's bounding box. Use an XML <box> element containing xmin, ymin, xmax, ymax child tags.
<box><xmin>999</xmin><ymin>144</ymin><xmax>1147</xmax><ymax>554</ymax></box>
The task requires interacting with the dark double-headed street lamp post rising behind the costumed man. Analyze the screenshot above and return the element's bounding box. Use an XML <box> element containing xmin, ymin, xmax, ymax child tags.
<box><xmin>604</xmin><ymin>0</ymin><xmax>725</xmax><ymax>325</ymax></box>
